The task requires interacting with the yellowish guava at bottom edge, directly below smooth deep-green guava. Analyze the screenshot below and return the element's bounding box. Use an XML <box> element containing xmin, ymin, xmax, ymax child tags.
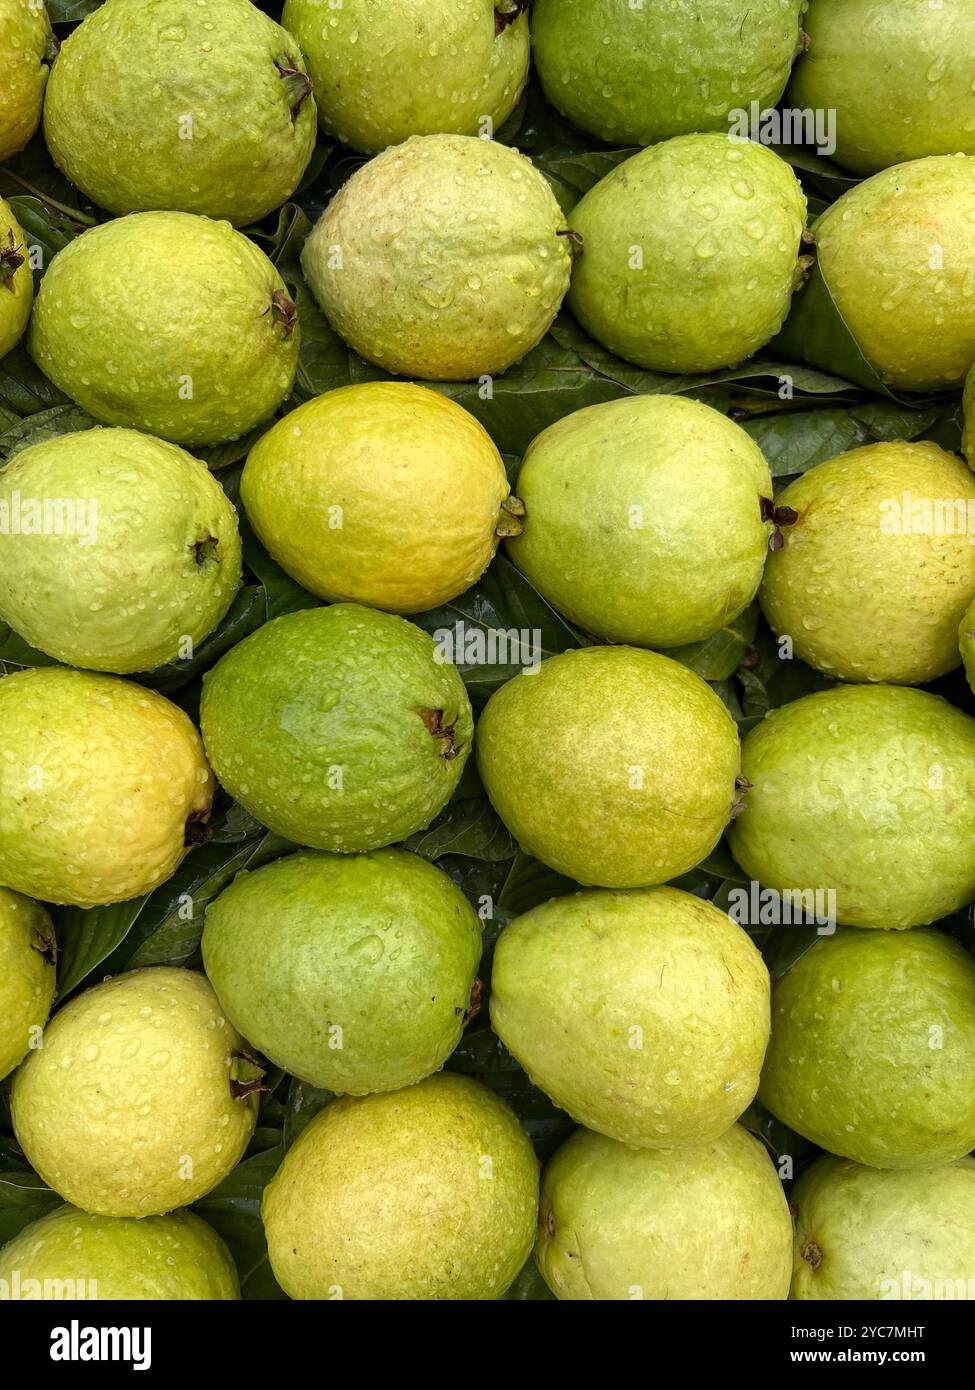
<box><xmin>261</xmin><ymin>1072</ymin><xmax>538</xmax><ymax>1301</ymax></box>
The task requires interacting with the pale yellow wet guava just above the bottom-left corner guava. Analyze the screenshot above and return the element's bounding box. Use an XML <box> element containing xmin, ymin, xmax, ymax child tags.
<box><xmin>11</xmin><ymin>966</ymin><xmax>260</xmax><ymax>1216</ymax></box>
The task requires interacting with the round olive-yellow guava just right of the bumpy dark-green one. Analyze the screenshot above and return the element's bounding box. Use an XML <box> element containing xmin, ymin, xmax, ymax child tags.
<box><xmin>476</xmin><ymin>646</ymin><xmax>740</xmax><ymax>888</ymax></box>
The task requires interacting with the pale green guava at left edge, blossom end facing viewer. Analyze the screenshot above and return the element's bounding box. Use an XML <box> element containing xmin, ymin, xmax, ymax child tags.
<box><xmin>0</xmin><ymin>430</ymin><xmax>241</xmax><ymax>674</ymax></box>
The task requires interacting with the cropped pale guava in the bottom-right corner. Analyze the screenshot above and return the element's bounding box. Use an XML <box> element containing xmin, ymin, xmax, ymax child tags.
<box><xmin>790</xmin><ymin>1154</ymin><xmax>975</xmax><ymax>1302</ymax></box>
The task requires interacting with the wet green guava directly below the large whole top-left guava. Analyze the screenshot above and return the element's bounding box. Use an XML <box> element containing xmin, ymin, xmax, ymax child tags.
<box><xmin>31</xmin><ymin>209</ymin><xmax>299</xmax><ymax>445</ymax></box>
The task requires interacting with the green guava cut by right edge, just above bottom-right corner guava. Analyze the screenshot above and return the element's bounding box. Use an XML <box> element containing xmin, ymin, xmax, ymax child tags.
<box><xmin>758</xmin><ymin>927</ymin><xmax>975</xmax><ymax>1168</ymax></box>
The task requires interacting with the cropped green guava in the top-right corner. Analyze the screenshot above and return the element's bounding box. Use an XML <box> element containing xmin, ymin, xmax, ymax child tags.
<box><xmin>787</xmin><ymin>0</ymin><xmax>975</xmax><ymax>175</ymax></box>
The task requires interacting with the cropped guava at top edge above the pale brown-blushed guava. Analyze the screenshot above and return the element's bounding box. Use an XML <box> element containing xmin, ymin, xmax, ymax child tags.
<box><xmin>282</xmin><ymin>0</ymin><xmax>530</xmax><ymax>154</ymax></box>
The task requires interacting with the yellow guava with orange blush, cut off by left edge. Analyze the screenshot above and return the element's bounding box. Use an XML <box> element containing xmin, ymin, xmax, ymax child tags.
<box><xmin>0</xmin><ymin>666</ymin><xmax>213</xmax><ymax>908</ymax></box>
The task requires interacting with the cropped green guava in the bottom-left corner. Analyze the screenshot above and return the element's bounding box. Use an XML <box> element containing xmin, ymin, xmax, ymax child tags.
<box><xmin>0</xmin><ymin>1207</ymin><xmax>241</xmax><ymax>1302</ymax></box>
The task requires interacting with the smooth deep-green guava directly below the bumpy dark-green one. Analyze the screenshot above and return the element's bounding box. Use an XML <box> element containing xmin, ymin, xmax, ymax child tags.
<box><xmin>203</xmin><ymin>849</ymin><xmax>481</xmax><ymax>1095</ymax></box>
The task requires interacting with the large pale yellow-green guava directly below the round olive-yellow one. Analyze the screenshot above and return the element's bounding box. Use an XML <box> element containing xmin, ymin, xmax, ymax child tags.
<box><xmin>491</xmin><ymin>888</ymin><xmax>769</xmax><ymax>1148</ymax></box>
